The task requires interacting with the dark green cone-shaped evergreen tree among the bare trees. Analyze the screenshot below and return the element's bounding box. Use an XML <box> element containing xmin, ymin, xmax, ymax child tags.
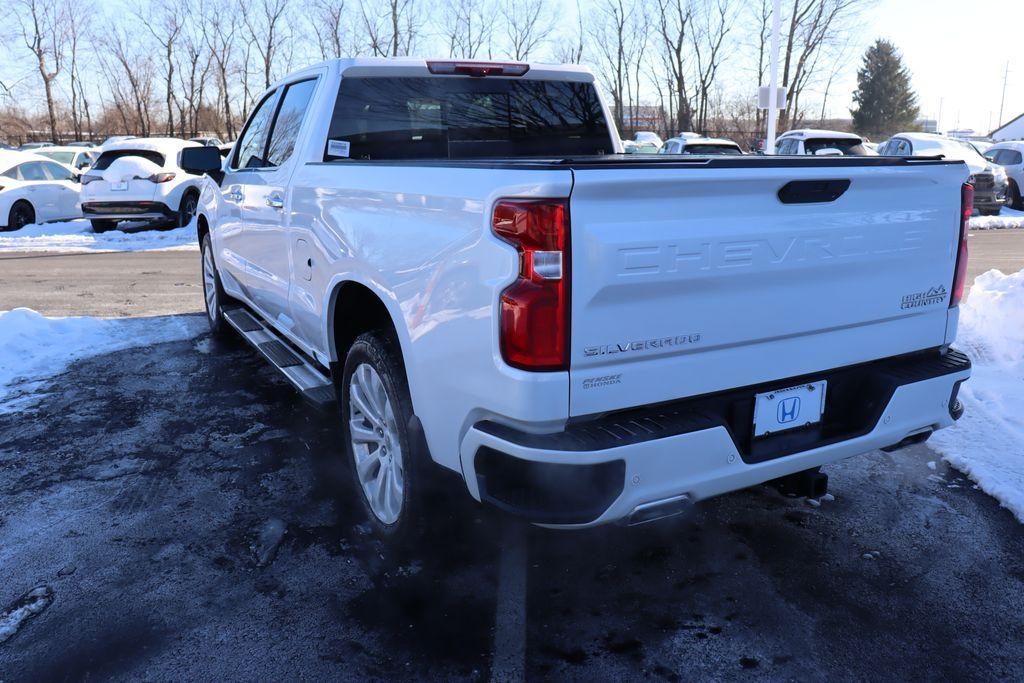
<box><xmin>850</xmin><ymin>40</ymin><xmax>919</xmax><ymax>140</ymax></box>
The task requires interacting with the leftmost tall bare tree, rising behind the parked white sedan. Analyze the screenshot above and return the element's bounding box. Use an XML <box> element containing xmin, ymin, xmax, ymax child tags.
<box><xmin>17</xmin><ymin>0</ymin><xmax>72</xmax><ymax>142</ymax></box>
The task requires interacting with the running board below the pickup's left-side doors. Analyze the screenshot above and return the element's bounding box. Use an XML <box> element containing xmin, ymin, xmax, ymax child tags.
<box><xmin>223</xmin><ymin>306</ymin><xmax>337</xmax><ymax>411</ymax></box>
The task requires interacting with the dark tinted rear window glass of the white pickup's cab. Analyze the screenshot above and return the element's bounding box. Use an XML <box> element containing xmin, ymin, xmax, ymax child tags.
<box><xmin>325</xmin><ymin>76</ymin><xmax>613</xmax><ymax>161</ymax></box>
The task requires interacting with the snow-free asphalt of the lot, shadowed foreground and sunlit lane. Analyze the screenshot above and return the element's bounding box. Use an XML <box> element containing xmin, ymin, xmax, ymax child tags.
<box><xmin>0</xmin><ymin>230</ymin><xmax>1024</xmax><ymax>681</ymax></box>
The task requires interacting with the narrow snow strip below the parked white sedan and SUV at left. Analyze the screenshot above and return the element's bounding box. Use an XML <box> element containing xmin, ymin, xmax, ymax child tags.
<box><xmin>0</xmin><ymin>218</ymin><xmax>199</xmax><ymax>252</ymax></box>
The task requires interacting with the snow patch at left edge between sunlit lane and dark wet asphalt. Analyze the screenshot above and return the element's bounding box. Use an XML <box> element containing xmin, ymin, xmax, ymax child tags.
<box><xmin>0</xmin><ymin>308</ymin><xmax>206</xmax><ymax>412</ymax></box>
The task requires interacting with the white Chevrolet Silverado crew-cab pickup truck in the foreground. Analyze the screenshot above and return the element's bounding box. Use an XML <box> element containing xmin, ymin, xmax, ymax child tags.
<box><xmin>182</xmin><ymin>58</ymin><xmax>971</xmax><ymax>537</ymax></box>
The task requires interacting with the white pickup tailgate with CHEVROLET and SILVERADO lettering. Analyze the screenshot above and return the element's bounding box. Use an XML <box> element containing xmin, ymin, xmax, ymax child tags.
<box><xmin>569</xmin><ymin>160</ymin><xmax>968</xmax><ymax>416</ymax></box>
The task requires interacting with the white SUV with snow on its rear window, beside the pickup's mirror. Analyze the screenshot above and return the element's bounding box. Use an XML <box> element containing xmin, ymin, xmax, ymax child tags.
<box><xmin>82</xmin><ymin>137</ymin><xmax>207</xmax><ymax>232</ymax></box>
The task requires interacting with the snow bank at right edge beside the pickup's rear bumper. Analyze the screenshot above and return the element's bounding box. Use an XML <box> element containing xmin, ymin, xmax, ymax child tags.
<box><xmin>929</xmin><ymin>270</ymin><xmax>1024</xmax><ymax>522</ymax></box>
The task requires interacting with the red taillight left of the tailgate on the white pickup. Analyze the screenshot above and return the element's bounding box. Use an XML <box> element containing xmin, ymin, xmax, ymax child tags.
<box><xmin>492</xmin><ymin>200</ymin><xmax>569</xmax><ymax>371</ymax></box>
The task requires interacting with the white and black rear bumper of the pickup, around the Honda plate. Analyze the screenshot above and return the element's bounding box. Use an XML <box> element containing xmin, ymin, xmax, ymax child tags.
<box><xmin>461</xmin><ymin>350</ymin><xmax>971</xmax><ymax>528</ymax></box>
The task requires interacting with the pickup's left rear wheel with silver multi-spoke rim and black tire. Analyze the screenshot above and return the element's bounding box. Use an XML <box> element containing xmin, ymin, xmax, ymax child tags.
<box><xmin>340</xmin><ymin>332</ymin><xmax>426</xmax><ymax>544</ymax></box>
